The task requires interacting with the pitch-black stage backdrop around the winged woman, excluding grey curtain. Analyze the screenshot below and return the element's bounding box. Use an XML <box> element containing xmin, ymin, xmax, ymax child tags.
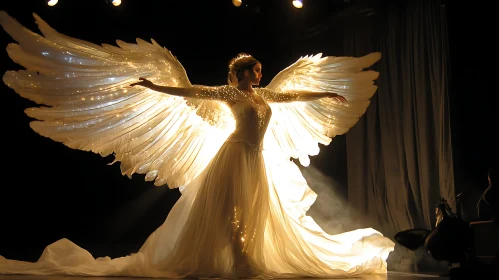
<box><xmin>0</xmin><ymin>0</ymin><xmax>498</xmax><ymax>261</ymax></box>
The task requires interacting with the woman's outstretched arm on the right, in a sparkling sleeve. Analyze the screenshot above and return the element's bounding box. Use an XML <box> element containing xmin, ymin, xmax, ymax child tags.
<box><xmin>257</xmin><ymin>88</ymin><xmax>346</xmax><ymax>102</ymax></box>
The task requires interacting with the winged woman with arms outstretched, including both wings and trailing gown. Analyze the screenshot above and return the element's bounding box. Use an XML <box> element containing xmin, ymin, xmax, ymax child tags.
<box><xmin>0</xmin><ymin>10</ymin><xmax>394</xmax><ymax>278</ymax></box>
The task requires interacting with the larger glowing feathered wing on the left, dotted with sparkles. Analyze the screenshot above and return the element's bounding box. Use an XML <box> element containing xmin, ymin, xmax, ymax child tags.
<box><xmin>0</xmin><ymin>11</ymin><xmax>235</xmax><ymax>188</ymax></box>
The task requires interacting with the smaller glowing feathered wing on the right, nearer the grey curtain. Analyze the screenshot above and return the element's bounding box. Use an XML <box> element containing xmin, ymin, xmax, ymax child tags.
<box><xmin>265</xmin><ymin>53</ymin><xmax>381</xmax><ymax>166</ymax></box>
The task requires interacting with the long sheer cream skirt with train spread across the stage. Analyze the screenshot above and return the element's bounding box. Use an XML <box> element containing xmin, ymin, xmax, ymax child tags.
<box><xmin>0</xmin><ymin>142</ymin><xmax>394</xmax><ymax>278</ymax></box>
